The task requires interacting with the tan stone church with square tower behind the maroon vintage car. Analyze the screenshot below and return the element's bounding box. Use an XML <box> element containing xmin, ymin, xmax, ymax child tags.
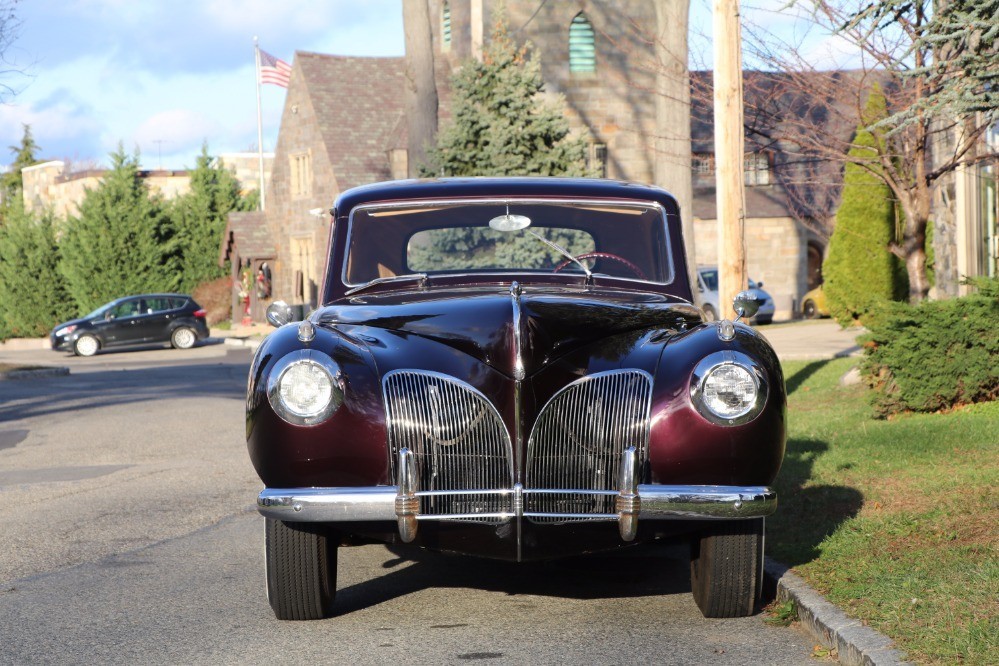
<box><xmin>220</xmin><ymin>0</ymin><xmax>826</xmax><ymax>321</ymax></box>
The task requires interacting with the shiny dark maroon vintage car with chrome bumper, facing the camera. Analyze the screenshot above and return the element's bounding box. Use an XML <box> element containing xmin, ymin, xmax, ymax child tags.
<box><xmin>246</xmin><ymin>178</ymin><xmax>786</xmax><ymax>620</ymax></box>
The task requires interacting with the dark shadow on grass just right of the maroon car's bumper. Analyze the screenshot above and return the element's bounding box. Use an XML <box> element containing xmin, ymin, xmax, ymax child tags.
<box><xmin>767</xmin><ymin>436</ymin><xmax>864</xmax><ymax>567</ymax></box>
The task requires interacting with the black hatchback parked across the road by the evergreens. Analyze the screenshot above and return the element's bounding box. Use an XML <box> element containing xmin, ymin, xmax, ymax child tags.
<box><xmin>49</xmin><ymin>294</ymin><xmax>208</xmax><ymax>356</ymax></box>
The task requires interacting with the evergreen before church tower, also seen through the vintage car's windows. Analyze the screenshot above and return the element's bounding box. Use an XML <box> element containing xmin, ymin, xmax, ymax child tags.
<box><xmin>413</xmin><ymin>17</ymin><xmax>593</xmax><ymax>269</ymax></box>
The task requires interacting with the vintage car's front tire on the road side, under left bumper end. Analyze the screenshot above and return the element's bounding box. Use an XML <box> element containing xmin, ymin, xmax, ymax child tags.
<box><xmin>264</xmin><ymin>518</ymin><xmax>337</xmax><ymax>620</ymax></box>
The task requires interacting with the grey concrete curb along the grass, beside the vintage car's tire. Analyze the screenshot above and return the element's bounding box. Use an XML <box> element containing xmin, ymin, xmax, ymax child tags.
<box><xmin>764</xmin><ymin>557</ymin><xmax>909</xmax><ymax>666</ymax></box>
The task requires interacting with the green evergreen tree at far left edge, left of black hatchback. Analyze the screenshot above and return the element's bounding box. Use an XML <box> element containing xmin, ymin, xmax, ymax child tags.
<box><xmin>0</xmin><ymin>200</ymin><xmax>76</xmax><ymax>339</ymax></box>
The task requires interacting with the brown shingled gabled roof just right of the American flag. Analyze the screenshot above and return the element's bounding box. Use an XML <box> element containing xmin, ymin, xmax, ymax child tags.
<box><xmin>295</xmin><ymin>52</ymin><xmax>406</xmax><ymax>190</ymax></box>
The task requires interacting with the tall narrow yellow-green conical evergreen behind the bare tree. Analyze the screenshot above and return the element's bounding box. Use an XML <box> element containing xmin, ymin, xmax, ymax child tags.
<box><xmin>822</xmin><ymin>86</ymin><xmax>908</xmax><ymax>326</ymax></box>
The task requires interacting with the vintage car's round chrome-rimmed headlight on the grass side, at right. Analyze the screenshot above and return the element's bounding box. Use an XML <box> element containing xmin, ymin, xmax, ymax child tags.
<box><xmin>690</xmin><ymin>352</ymin><xmax>767</xmax><ymax>425</ymax></box>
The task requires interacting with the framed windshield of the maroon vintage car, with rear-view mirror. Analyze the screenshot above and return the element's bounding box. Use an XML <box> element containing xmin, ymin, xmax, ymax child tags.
<box><xmin>343</xmin><ymin>199</ymin><xmax>673</xmax><ymax>286</ymax></box>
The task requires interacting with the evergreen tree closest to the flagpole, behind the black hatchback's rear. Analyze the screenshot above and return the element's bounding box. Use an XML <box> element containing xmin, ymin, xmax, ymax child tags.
<box><xmin>170</xmin><ymin>145</ymin><xmax>250</xmax><ymax>291</ymax></box>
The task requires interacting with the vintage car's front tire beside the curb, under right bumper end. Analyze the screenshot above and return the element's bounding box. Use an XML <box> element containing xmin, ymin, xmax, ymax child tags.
<box><xmin>690</xmin><ymin>518</ymin><xmax>764</xmax><ymax>617</ymax></box>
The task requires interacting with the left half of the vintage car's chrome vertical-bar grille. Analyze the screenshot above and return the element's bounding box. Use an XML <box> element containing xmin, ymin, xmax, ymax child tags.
<box><xmin>382</xmin><ymin>370</ymin><xmax>513</xmax><ymax>522</ymax></box>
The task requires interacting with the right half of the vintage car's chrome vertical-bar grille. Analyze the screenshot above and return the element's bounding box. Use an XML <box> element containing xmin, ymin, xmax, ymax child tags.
<box><xmin>524</xmin><ymin>370</ymin><xmax>652</xmax><ymax>523</ymax></box>
